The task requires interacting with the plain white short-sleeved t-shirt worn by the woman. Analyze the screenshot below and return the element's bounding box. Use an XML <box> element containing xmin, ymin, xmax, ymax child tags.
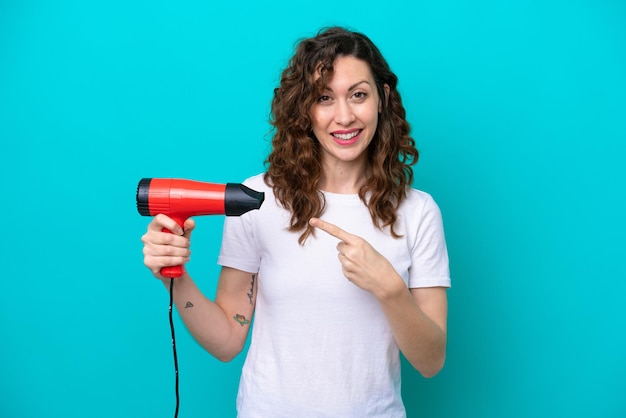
<box><xmin>218</xmin><ymin>175</ymin><xmax>450</xmax><ymax>418</ymax></box>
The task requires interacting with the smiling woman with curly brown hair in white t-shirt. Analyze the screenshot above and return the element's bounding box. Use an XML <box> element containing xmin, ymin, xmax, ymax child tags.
<box><xmin>142</xmin><ymin>28</ymin><xmax>450</xmax><ymax>418</ymax></box>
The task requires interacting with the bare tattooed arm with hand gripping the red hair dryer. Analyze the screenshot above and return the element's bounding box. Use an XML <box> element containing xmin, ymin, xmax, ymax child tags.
<box><xmin>142</xmin><ymin>215</ymin><xmax>257</xmax><ymax>361</ymax></box>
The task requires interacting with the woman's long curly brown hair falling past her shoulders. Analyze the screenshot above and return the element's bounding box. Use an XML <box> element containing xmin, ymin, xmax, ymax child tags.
<box><xmin>265</xmin><ymin>27</ymin><xmax>419</xmax><ymax>245</ymax></box>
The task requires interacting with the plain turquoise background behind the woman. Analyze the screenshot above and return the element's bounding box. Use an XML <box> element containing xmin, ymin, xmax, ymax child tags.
<box><xmin>0</xmin><ymin>0</ymin><xmax>626</xmax><ymax>418</ymax></box>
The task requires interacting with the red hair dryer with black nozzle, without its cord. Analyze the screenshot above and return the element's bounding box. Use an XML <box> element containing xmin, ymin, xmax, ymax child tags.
<box><xmin>137</xmin><ymin>178</ymin><xmax>265</xmax><ymax>278</ymax></box>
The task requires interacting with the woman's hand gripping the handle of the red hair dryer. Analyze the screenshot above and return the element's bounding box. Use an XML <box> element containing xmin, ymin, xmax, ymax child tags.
<box><xmin>141</xmin><ymin>214</ymin><xmax>196</xmax><ymax>280</ymax></box>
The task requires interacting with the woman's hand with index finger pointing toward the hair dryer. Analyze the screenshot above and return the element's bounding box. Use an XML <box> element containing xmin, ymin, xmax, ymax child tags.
<box><xmin>309</xmin><ymin>218</ymin><xmax>406</xmax><ymax>298</ymax></box>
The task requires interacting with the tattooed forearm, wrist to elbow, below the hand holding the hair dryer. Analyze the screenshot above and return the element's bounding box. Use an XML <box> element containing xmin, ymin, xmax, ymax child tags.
<box><xmin>164</xmin><ymin>273</ymin><xmax>242</xmax><ymax>361</ymax></box>
